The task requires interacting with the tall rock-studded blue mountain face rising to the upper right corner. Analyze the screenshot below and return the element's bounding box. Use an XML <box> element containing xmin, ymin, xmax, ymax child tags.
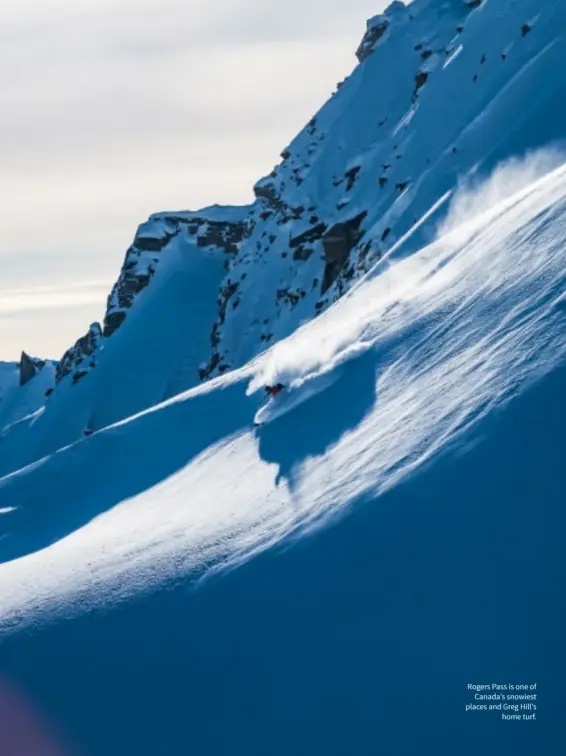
<box><xmin>207</xmin><ymin>0</ymin><xmax>566</xmax><ymax>375</ymax></box>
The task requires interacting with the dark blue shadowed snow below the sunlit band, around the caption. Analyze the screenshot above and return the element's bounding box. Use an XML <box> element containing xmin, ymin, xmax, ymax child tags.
<box><xmin>2</xmin><ymin>367</ymin><xmax>566</xmax><ymax>756</ymax></box>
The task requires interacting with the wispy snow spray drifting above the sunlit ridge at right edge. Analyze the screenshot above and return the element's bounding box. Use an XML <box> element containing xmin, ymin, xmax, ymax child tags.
<box><xmin>436</xmin><ymin>145</ymin><xmax>566</xmax><ymax>238</ymax></box>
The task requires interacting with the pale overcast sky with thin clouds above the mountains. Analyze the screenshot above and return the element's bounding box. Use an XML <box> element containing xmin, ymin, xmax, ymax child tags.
<box><xmin>0</xmin><ymin>0</ymin><xmax>387</xmax><ymax>359</ymax></box>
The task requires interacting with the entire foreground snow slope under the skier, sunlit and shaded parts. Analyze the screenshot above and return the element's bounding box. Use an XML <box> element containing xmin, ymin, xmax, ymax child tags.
<box><xmin>0</xmin><ymin>155</ymin><xmax>566</xmax><ymax>756</ymax></box>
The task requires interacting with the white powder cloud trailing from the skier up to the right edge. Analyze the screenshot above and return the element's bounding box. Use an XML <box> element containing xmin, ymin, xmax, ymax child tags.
<box><xmin>248</xmin><ymin>147</ymin><xmax>566</xmax><ymax>402</ymax></box>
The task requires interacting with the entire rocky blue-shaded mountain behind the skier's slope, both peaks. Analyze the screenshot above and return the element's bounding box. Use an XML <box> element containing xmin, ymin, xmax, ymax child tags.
<box><xmin>5</xmin><ymin>0</ymin><xmax>566</xmax><ymax>474</ymax></box>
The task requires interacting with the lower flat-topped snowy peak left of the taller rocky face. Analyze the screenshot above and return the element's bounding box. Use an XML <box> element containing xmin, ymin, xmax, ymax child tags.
<box><xmin>0</xmin><ymin>206</ymin><xmax>251</xmax><ymax>474</ymax></box>
